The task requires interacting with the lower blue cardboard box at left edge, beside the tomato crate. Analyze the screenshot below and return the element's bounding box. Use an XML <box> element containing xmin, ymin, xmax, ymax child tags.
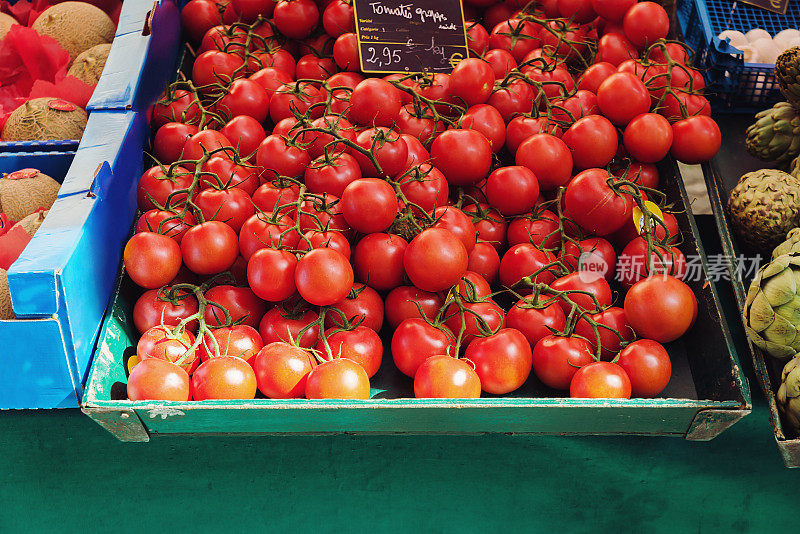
<box><xmin>0</xmin><ymin>111</ymin><xmax>148</xmax><ymax>409</ymax></box>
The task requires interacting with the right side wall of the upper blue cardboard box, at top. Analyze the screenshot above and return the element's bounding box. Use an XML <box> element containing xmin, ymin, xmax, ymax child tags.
<box><xmin>87</xmin><ymin>0</ymin><xmax>180</xmax><ymax>111</ymax></box>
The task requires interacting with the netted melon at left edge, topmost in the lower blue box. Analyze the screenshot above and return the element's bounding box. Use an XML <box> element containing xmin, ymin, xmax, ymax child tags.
<box><xmin>0</xmin><ymin>169</ymin><xmax>61</xmax><ymax>223</ymax></box>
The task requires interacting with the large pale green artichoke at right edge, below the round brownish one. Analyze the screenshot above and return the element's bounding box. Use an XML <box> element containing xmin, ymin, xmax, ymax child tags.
<box><xmin>743</xmin><ymin>253</ymin><xmax>800</xmax><ymax>359</ymax></box>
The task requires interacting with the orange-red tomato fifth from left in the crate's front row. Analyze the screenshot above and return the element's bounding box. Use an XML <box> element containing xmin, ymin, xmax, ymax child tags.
<box><xmin>414</xmin><ymin>354</ymin><xmax>481</xmax><ymax>399</ymax></box>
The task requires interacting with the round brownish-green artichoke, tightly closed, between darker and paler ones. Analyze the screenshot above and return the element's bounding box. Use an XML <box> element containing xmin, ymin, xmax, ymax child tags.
<box><xmin>728</xmin><ymin>169</ymin><xmax>800</xmax><ymax>252</ymax></box>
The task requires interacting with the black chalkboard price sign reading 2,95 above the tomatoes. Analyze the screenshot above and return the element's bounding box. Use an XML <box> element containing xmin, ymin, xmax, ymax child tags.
<box><xmin>353</xmin><ymin>0</ymin><xmax>468</xmax><ymax>73</ymax></box>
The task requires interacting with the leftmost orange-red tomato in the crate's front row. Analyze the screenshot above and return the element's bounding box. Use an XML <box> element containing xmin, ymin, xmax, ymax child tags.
<box><xmin>128</xmin><ymin>358</ymin><xmax>191</xmax><ymax>402</ymax></box>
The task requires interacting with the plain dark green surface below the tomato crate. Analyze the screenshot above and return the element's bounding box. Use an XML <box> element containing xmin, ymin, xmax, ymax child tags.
<box><xmin>0</xmin><ymin>216</ymin><xmax>788</xmax><ymax>534</ymax></box>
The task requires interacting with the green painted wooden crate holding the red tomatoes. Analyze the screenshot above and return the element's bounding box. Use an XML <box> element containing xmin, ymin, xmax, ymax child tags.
<box><xmin>82</xmin><ymin>163</ymin><xmax>751</xmax><ymax>441</ymax></box>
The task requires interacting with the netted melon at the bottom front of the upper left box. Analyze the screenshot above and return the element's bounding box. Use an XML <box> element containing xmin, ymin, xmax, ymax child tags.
<box><xmin>2</xmin><ymin>97</ymin><xmax>88</xmax><ymax>141</ymax></box>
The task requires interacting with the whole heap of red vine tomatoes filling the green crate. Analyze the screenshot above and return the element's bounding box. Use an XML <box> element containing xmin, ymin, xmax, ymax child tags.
<box><xmin>124</xmin><ymin>0</ymin><xmax>720</xmax><ymax>401</ymax></box>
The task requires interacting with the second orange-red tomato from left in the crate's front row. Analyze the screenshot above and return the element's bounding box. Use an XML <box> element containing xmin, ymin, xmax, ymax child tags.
<box><xmin>192</xmin><ymin>356</ymin><xmax>256</xmax><ymax>401</ymax></box>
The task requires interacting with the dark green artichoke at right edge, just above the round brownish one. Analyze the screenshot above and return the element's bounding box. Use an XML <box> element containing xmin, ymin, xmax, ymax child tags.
<box><xmin>745</xmin><ymin>102</ymin><xmax>800</xmax><ymax>166</ymax></box>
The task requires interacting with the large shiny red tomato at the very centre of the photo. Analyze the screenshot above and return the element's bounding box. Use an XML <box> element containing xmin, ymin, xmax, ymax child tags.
<box><xmin>403</xmin><ymin>227</ymin><xmax>471</xmax><ymax>292</ymax></box>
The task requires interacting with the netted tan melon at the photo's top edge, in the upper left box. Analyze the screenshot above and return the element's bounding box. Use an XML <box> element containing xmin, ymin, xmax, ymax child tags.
<box><xmin>32</xmin><ymin>2</ymin><xmax>116</xmax><ymax>60</ymax></box>
